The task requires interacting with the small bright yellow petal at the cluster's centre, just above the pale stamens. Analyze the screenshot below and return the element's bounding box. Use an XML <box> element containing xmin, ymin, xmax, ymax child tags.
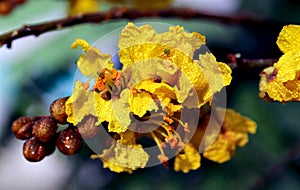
<box><xmin>128</xmin><ymin>91</ymin><xmax>158</xmax><ymax>117</ymax></box>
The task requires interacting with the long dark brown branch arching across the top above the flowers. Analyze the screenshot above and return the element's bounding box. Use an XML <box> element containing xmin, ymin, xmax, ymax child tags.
<box><xmin>0</xmin><ymin>8</ymin><xmax>285</xmax><ymax>48</ymax></box>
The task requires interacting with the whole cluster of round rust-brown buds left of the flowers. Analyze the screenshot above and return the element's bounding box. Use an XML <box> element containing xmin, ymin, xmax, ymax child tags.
<box><xmin>12</xmin><ymin>97</ymin><xmax>99</xmax><ymax>162</ymax></box>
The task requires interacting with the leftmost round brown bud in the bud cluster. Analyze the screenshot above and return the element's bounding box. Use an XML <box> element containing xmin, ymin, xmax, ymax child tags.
<box><xmin>11</xmin><ymin>116</ymin><xmax>38</xmax><ymax>140</ymax></box>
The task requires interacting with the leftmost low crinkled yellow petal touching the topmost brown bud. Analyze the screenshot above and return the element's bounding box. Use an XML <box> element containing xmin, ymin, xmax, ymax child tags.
<box><xmin>65</xmin><ymin>81</ymin><xmax>97</xmax><ymax>125</ymax></box>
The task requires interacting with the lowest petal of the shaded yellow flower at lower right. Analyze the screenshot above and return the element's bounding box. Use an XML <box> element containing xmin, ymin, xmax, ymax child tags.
<box><xmin>203</xmin><ymin>135</ymin><xmax>235</xmax><ymax>163</ymax></box>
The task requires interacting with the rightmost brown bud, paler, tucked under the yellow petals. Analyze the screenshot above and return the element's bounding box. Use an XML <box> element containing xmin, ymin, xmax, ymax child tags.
<box><xmin>77</xmin><ymin>115</ymin><xmax>99</xmax><ymax>139</ymax></box>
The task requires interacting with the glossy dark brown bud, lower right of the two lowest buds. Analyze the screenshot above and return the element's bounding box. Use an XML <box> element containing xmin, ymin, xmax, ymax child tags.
<box><xmin>56</xmin><ymin>126</ymin><xmax>82</xmax><ymax>155</ymax></box>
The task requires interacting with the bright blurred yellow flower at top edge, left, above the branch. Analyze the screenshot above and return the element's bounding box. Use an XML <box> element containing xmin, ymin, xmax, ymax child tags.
<box><xmin>69</xmin><ymin>0</ymin><xmax>99</xmax><ymax>16</ymax></box>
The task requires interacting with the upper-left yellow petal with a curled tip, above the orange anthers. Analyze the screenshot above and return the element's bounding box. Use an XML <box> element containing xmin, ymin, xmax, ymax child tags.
<box><xmin>71</xmin><ymin>39</ymin><xmax>113</xmax><ymax>77</ymax></box>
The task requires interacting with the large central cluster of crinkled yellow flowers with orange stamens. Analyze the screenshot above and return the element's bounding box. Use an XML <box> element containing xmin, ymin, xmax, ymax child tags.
<box><xmin>66</xmin><ymin>23</ymin><xmax>256</xmax><ymax>173</ymax></box>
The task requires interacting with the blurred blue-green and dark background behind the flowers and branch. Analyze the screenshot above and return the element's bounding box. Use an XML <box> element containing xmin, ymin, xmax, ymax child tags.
<box><xmin>0</xmin><ymin>0</ymin><xmax>300</xmax><ymax>190</ymax></box>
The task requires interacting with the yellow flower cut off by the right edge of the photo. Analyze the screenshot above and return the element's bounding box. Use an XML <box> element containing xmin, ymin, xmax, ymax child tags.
<box><xmin>259</xmin><ymin>25</ymin><xmax>300</xmax><ymax>102</ymax></box>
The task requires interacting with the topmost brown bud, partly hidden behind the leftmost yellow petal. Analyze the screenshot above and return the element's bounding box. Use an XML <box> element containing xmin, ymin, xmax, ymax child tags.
<box><xmin>50</xmin><ymin>97</ymin><xmax>69</xmax><ymax>124</ymax></box>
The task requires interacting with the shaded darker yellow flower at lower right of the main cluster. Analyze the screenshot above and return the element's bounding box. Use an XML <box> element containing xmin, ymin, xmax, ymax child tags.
<box><xmin>203</xmin><ymin>109</ymin><xmax>256</xmax><ymax>163</ymax></box>
